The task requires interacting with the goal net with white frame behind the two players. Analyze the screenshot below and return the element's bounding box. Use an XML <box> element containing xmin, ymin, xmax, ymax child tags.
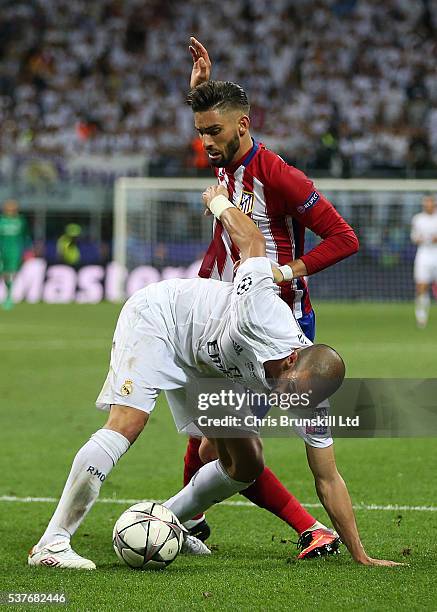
<box><xmin>113</xmin><ymin>177</ymin><xmax>437</xmax><ymax>301</ymax></box>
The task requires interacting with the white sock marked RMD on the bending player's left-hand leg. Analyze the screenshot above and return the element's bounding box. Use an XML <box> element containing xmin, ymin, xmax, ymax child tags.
<box><xmin>37</xmin><ymin>429</ymin><xmax>130</xmax><ymax>548</ymax></box>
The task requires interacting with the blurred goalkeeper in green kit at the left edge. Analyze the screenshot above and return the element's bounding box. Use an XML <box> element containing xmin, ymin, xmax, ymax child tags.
<box><xmin>0</xmin><ymin>200</ymin><xmax>30</xmax><ymax>310</ymax></box>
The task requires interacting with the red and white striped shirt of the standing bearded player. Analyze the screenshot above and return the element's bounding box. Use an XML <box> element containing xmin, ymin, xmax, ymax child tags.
<box><xmin>199</xmin><ymin>142</ymin><xmax>358</xmax><ymax>319</ymax></box>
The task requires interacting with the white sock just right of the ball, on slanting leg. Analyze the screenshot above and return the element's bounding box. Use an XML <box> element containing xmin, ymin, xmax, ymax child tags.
<box><xmin>163</xmin><ymin>459</ymin><xmax>253</xmax><ymax>523</ymax></box>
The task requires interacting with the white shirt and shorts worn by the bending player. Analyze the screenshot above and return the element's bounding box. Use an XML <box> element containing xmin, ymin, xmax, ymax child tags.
<box><xmin>96</xmin><ymin>257</ymin><xmax>332</xmax><ymax>446</ymax></box>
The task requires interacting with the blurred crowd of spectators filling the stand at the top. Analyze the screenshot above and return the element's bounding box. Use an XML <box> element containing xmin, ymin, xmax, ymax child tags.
<box><xmin>0</xmin><ymin>0</ymin><xmax>437</xmax><ymax>176</ymax></box>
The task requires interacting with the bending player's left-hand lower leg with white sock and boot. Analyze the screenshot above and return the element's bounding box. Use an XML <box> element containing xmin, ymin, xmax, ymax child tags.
<box><xmin>28</xmin><ymin>405</ymin><xmax>149</xmax><ymax>569</ymax></box>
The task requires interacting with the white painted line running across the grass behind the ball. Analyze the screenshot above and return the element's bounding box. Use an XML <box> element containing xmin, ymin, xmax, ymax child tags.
<box><xmin>0</xmin><ymin>495</ymin><xmax>437</xmax><ymax>512</ymax></box>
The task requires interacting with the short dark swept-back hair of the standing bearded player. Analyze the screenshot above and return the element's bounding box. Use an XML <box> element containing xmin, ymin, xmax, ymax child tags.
<box><xmin>187</xmin><ymin>81</ymin><xmax>250</xmax><ymax>114</ymax></box>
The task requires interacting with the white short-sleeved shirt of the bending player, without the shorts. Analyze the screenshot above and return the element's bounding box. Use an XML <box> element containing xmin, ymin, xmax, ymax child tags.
<box><xmin>143</xmin><ymin>257</ymin><xmax>311</xmax><ymax>389</ymax></box>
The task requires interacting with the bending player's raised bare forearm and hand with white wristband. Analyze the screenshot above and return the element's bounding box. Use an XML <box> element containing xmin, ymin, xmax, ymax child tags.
<box><xmin>202</xmin><ymin>185</ymin><xmax>266</xmax><ymax>263</ymax></box>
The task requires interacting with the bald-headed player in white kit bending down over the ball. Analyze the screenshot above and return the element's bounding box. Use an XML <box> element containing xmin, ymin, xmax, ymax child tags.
<box><xmin>28</xmin><ymin>185</ymin><xmax>402</xmax><ymax>569</ymax></box>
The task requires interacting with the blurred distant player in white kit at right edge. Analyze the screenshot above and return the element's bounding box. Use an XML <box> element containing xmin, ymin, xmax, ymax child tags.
<box><xmin>411</xmin><ymin>196</ymin><xmax>437</xmax><ymax>328</ymax></box>
